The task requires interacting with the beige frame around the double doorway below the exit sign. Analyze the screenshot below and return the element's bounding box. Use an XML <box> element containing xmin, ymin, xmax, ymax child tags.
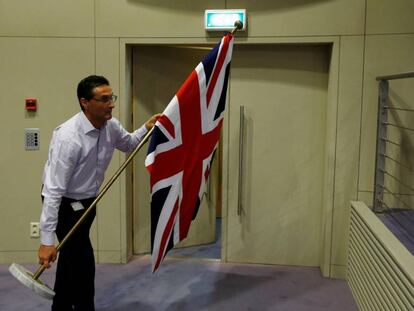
<box><xmin>120</xmin><ymin>36</ymin><xmax>340</xmax><ymax>277</ymax></box>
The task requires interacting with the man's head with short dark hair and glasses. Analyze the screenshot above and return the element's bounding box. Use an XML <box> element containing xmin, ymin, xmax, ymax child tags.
<box><xmin>77</xmin><ymin>75</ymin><xmax>116</xmax><ymax>128</ymax></box>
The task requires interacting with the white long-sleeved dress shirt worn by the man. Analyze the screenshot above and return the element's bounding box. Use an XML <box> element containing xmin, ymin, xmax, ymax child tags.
<box><xmin>40</xmin><ymin>112</ymin><xmax>147</xmax><ymax>245</ymax></box>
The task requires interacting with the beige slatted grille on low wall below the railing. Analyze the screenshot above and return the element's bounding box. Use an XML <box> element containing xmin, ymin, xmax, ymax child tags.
<box><xmin>347</xmin><ymin>202</ymin><xmax>414</xmax><ymax>311</ymax></box>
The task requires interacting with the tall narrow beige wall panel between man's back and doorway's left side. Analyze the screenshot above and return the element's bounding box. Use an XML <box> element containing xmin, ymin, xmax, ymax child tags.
<box><xmin>96</xmin><ymin>38</ymin><xmax>125</xmax><ymax>256</ymax></box>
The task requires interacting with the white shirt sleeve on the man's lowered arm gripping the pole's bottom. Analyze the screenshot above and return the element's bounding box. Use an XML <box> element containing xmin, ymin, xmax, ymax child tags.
<box><xmin>40</xmin><ymin>134</ymin><xmax>80</xmax><ymax>245</ymax></box>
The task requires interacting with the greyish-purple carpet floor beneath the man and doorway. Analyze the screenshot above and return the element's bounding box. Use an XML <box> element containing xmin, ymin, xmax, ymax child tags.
<box><xmin>0</xmin><ymin>256</ymin><xmax>358</xmax><ymax>311</ymax></box>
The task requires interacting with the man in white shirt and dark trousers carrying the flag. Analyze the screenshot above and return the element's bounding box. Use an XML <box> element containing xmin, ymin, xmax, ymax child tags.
<box><xmin>38</xmin><ymin>75</ymin><xmax>160</xmax><ymax>311</ymax></box>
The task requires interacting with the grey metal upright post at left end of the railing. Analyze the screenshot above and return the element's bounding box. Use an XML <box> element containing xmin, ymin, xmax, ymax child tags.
<box><xmin>373</xmin><ymin>80</ymin><xmax>389</xmax><ymax>212</ymax></box>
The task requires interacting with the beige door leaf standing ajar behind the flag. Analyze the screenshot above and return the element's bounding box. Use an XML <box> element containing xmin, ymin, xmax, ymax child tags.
<box><xmin>132</xmin><ymin>46</ymin><xmax>218</xmax><ymax>254</ymax></box>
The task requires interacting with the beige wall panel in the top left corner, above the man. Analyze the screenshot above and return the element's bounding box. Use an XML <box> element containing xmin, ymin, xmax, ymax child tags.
<box><xmin>0</xmin><ymin>0</ymin><xmax>94</xmax><ymax>37</ymax></box>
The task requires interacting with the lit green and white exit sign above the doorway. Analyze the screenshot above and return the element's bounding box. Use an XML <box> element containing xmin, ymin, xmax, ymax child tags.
<box><xmin>204</xmin><ymin>9</ymin><xmax>246</xmax><ymax>31</ymax></box>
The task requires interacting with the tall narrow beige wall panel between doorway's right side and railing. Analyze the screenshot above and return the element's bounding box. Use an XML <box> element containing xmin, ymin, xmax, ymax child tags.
<box><xmin>331</xmin><ymin>36</ymin><xmax>364</xmax><ymax>265</ymax></box>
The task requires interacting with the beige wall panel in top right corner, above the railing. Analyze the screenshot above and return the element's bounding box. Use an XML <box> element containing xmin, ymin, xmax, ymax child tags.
<box><xmin>366</xmin><ymin>0</ymin><xmax>414</xmax><ymax>34</ymax></box>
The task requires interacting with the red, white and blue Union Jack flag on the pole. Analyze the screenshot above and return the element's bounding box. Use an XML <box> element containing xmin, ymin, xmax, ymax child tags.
<box><xmin>145</xmin><ymin>34</ymin><xmax>233</xmax><ymax>272</ymax></box>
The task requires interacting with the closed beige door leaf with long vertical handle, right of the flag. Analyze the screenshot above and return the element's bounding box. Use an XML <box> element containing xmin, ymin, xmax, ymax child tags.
<box><xmin>225</xmin><ymin>45</ymin><xmax>330</xmax><ymax>266</ymax></box>
